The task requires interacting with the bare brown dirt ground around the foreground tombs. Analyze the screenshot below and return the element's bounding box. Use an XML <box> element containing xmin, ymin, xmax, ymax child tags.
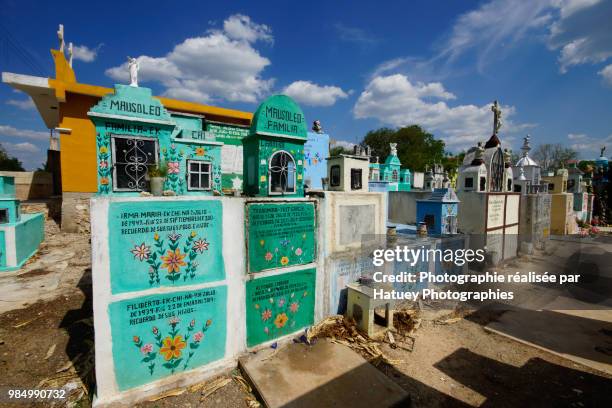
<box><xmin>0</xmin><ymin>221</ymin><xmax>612</xmax><ymax>408</ymax></box>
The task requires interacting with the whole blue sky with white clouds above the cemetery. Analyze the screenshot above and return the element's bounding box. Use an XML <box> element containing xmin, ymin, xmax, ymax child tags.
<box><xmin>0</xmin><ymin>0</ymin><xmax>612</xmax><ymax>168</ymax></box>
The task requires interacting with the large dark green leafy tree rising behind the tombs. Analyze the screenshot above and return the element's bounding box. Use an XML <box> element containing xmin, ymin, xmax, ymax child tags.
<box><xmin>362</xmin><ymin>125</ymin><xmax>444</xmax><ymax>171</ymax></box>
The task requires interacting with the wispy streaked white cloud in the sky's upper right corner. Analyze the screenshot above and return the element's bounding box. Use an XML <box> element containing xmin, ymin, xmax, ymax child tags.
<box><xmin>373</xmin><ymin>0</ymin><xmax>612</xmax><ymax>80</ymax></box>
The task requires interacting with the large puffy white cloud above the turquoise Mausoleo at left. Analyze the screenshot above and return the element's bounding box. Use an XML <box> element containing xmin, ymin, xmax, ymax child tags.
<box><xmin>106</xmin><ymin>14</ymin><xmax>274</xmax><ymax>103</ymax></box>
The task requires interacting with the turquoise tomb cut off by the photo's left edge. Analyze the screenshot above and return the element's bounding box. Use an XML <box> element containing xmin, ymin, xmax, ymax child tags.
<box><xmin>0</xmin><ymin>176</ymin><xmax>45</xmax><ymax>272</ymax></box>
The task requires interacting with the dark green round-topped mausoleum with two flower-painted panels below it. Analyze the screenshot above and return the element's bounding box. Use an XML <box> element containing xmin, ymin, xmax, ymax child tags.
<box><xmin>243</xmin><ymin>95</ymin><xmax>319</xmax><ymax>347</ymax></box>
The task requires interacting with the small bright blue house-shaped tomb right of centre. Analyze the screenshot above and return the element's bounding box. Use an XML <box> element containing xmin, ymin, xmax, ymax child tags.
<box><xmin>417</xmin><ymin>188</ymin><xmax>459</xmax><ymax>235</ymax></box>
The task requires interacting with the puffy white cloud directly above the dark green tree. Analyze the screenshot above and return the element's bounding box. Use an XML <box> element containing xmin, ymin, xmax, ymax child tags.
<box><xmin>353</xmin><ymin>74</ymin><xmax>520</xmax><ymax>148</ymax></box>
